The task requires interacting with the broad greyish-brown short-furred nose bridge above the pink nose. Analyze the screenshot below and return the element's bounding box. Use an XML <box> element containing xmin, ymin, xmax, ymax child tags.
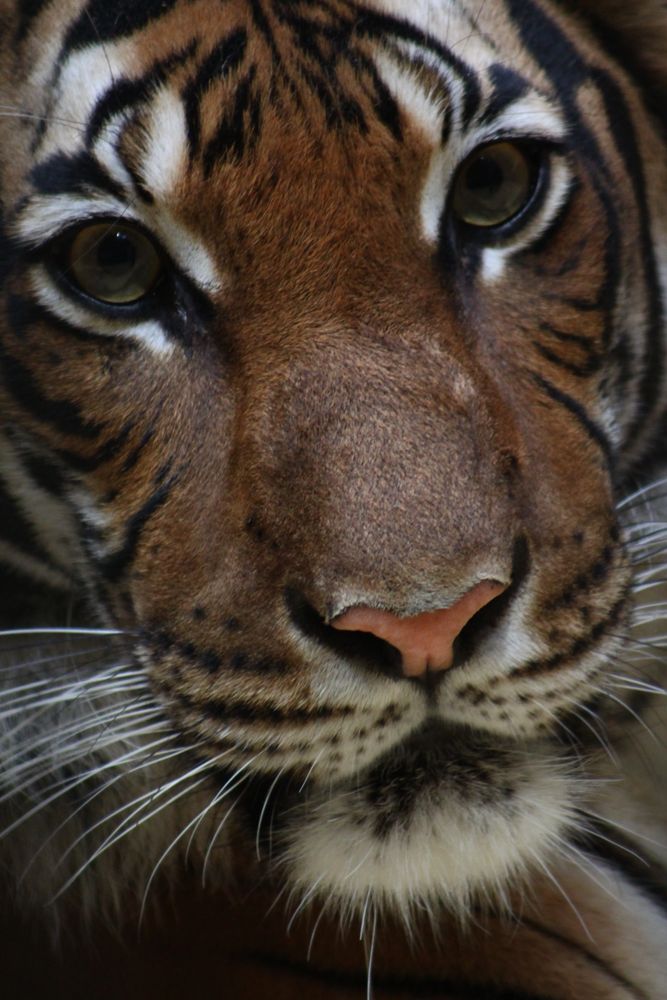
<box><xmin>236</xmin><ymin>324</ymin><xmax>514</xmax><ymax>619</ymax></box>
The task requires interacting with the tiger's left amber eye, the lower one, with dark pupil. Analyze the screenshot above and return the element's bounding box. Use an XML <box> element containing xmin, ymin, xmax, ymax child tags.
<box><xmin>66</xmin><ymin>222</ymin><xmax>162</xmax><ymax>305</ymax></box>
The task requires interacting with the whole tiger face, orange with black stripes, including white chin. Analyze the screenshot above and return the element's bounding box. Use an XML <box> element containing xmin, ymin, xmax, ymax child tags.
<box><xmin>0</xmin><ymin>0</ymin><xmax>667</xmax><ymax>907</ymax></box>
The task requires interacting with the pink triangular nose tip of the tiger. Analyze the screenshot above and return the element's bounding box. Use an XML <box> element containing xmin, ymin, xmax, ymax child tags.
<box><xmin>331</xmin><ymin>580</ymin><xmax>506</xmax><ymax>677</ymax></box>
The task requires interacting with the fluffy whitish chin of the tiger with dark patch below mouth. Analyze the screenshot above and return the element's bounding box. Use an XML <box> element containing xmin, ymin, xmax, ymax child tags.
<box><xmin>274</xmin><ymin>722</ymin><xmax>580</xmax><ymax>918</ymax></box>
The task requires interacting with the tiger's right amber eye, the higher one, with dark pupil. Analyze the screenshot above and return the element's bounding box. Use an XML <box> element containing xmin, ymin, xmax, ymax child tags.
<box><xmin>452</xmin><ymin>142</ymin><xmax>536</xmax><ymax>229</ymax></box>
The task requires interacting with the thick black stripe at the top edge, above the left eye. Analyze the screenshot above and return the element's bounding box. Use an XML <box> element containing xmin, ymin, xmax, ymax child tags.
<box><xmin>60</xmin><ymin>0</ymin><xmax>178</xmax><ymax>60</ymax></box>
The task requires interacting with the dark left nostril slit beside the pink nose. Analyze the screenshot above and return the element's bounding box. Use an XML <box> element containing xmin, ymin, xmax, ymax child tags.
<box><xmin>285</xmin><ymin>587</ymin><xmax>402</xmax><ymax>678</ymax></box>
